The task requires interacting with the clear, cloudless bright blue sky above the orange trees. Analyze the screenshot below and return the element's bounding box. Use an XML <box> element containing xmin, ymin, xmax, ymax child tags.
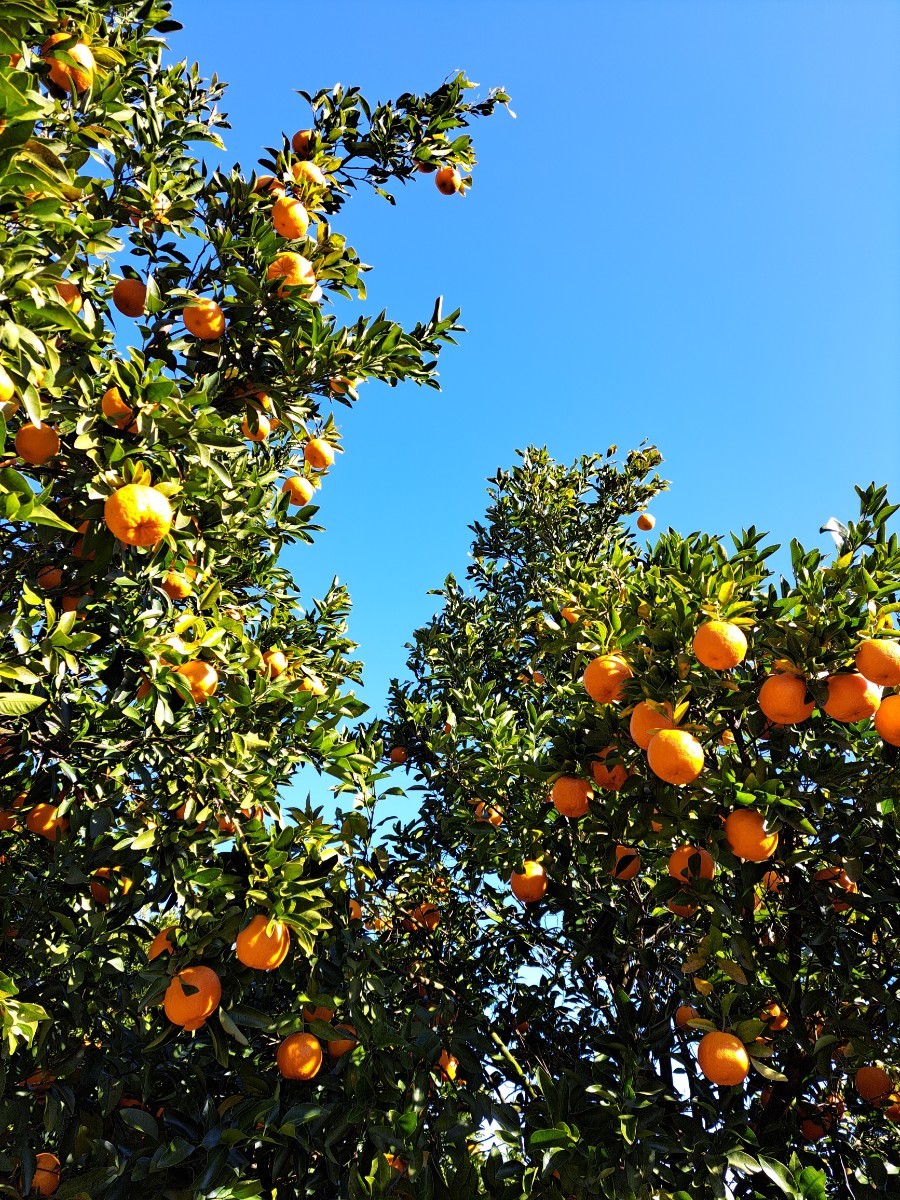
<box><xmin>172</xmin><ymin>0</ymin><xmax>900</xmax><ymax>806</ymax></box>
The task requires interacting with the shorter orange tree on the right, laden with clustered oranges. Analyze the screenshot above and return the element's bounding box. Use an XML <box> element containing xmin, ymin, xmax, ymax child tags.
<box><xmin>385</xmin><ymin>448</ymin><xmax>900</xmax><ymax>1200</ymax></box>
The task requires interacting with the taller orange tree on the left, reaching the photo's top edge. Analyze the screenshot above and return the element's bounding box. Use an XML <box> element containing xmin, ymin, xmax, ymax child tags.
<box><xmin>0</xmin><ymin>0</ymin><xmax>505</xmax><ymax>1198</ymax></box>
